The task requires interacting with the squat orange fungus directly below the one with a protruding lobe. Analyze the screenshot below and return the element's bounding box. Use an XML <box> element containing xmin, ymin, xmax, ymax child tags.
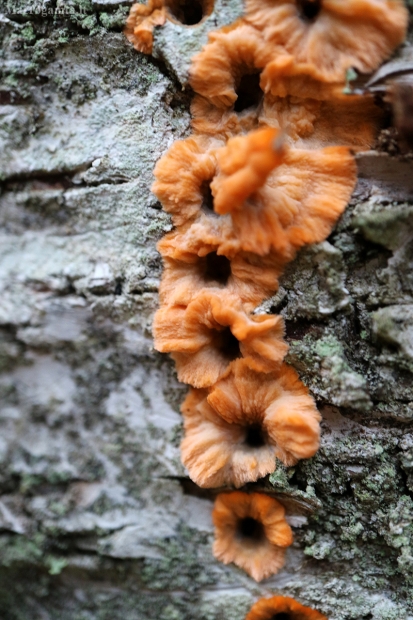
<box><xmin>158</xmin><ymin>229</ymin><xmax>284</xmax><ymax>311</ymax></box>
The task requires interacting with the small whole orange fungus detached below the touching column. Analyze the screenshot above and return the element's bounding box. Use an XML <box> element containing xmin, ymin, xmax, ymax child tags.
<box><xmin>212</xmin><ymin>491</ymin><xmax>293</xmax><ymax>581</ymax></box>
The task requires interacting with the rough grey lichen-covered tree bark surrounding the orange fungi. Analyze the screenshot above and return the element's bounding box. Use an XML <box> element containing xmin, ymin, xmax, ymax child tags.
<box><xmin>0</xmin><ymin>0</ymin><xmax>413</xmax><ymax>620</ymax></box>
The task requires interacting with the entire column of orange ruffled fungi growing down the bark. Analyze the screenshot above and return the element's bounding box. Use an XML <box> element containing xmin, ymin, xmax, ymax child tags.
<box><xmin>126</xmin><ymin>0</ymin><xmax>407</xmax><ymax>620</ymax></box>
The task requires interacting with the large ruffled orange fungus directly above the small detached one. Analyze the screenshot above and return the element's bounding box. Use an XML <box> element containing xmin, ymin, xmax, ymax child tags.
<box><xmin>181</xmin><ymin>360</ymin><xmax>320</xmax><ymax>488</ymax></box>
